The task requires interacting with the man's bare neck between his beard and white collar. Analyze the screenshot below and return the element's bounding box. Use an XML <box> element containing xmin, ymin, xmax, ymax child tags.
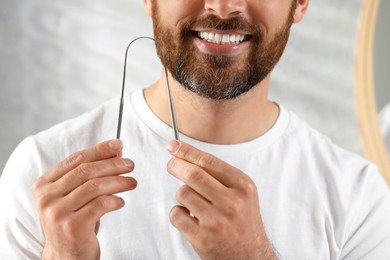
<box><xmin>144</xmin><ymin>73</ymin><xmax>279</xmax><ymax>144</ymax></box>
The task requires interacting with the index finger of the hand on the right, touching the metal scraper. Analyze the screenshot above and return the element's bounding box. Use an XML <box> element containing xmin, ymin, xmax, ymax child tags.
<box><xmin>166</xmin><ymin>140</ymin><xmax>248</xmax><ymax>187</ymax></box>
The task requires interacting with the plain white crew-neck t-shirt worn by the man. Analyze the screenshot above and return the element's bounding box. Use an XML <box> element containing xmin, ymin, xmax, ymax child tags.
<box><xmin>0</xmin><ymin>91</ymin><xmax>390</xmax><ymax>260</ymax></box>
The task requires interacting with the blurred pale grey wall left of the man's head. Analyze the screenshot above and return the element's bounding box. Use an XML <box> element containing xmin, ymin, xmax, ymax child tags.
<box><xmin>0</xmin><ymin>0</ymin><xmax>160</xmax><ymax>172</ymax></box>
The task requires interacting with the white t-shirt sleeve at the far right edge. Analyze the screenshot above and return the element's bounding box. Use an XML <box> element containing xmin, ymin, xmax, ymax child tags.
<box><xmin>339</xmin><ymin>165</ymin><xmax>390</xmax><ymax>260</ymax></box>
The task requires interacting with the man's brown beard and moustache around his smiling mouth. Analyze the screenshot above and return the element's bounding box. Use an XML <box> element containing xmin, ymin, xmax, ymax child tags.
<box><xmin>153</xmin><ymin>0</ymin><xmax>296</xmax><ymax>100</ymax></box>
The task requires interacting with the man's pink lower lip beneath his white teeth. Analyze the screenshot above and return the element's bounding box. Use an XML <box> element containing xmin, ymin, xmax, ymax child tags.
<box><xmin>194</xmin><ymin>36</ymin><xmax>249</xmax><ymax>56</ymax></box>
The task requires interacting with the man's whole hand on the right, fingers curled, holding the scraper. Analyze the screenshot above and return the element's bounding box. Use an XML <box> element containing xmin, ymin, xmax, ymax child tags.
<box><xmin>167</xmin><ymin>141</ymin><xmax>276</xmax><ymax>259</ymax></box>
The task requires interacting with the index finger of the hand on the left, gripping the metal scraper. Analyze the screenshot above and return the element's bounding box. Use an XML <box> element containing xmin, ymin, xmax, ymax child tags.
<box><xmin>42</xmin><ymin>139</ymin><xmax>123</xmax><ymax>182</ymax></box>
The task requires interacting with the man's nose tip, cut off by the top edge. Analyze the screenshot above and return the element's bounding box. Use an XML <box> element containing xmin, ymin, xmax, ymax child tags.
<box><xmin>205</xmin><ymin>0</ymin><xmax>247</xmax><ymax>19</ymax></box>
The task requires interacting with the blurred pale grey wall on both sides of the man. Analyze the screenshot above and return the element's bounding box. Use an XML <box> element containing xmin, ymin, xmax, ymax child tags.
<box><xmin>0</xmin><ymin>0</ymin><xmax>384</xmax><ymax>173</ymax></box>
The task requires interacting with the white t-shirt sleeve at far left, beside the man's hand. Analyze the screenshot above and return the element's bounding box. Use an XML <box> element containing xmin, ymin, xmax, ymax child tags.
<box><xmin>0</xmin><ymin>137</ymin><xmax>44</xmax><ymax>259</ymax></box>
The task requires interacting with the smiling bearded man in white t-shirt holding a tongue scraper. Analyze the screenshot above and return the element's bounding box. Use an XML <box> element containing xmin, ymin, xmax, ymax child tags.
<box><xmin>0</xmin><ymin>0</ymin><xmax>390</xmax><ymax>259</ymax></box>
